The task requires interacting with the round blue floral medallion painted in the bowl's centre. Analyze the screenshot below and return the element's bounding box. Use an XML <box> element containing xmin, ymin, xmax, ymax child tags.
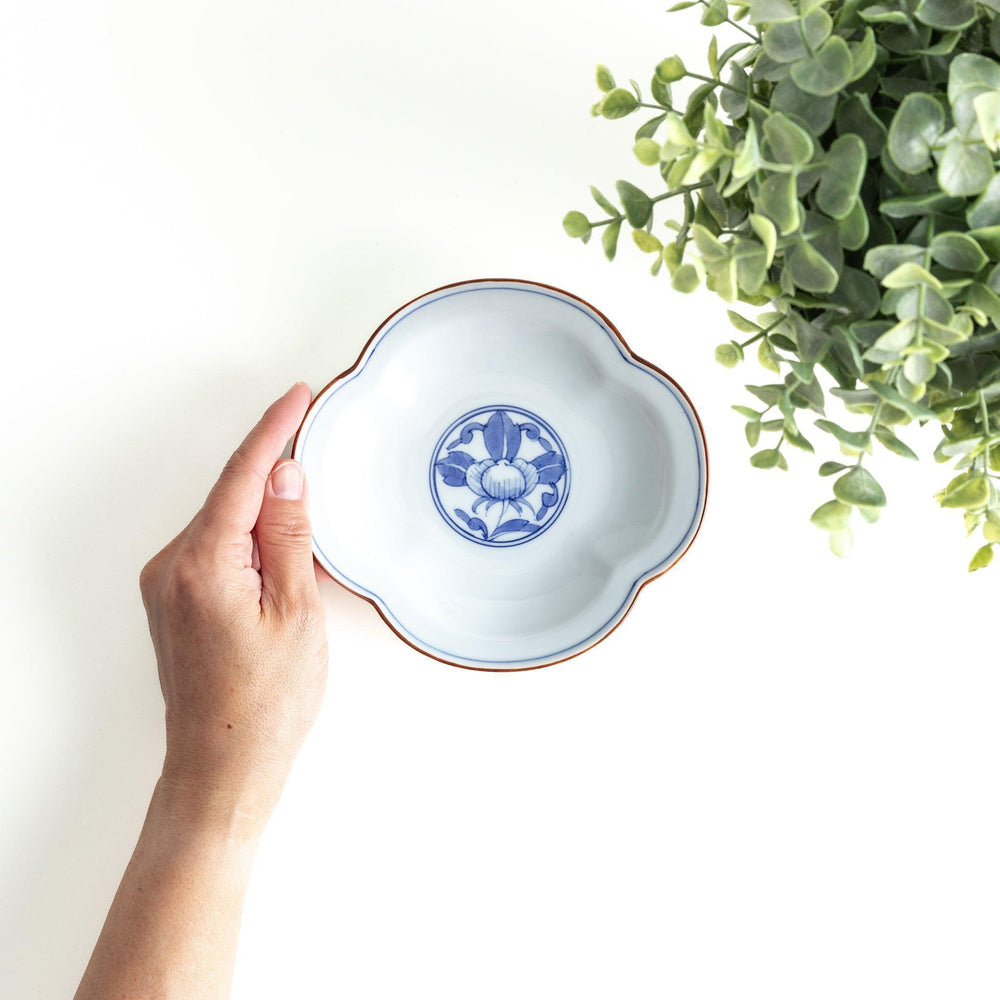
<box><xmin>431</xmin><ymin>406</ymin><xmax>569</xmax><ymax>546</ymax></box>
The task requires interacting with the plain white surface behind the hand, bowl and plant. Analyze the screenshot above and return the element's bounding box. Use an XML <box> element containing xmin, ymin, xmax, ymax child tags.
<box><xmin>0</xmin><ymin>0</ymin><xmax>1000</xmax><ymax>1000</ymax></box>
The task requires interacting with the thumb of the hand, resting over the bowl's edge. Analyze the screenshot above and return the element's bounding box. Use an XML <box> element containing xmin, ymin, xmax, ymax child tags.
<box><xmin>255</xmin><ymin>459</ymin><xmax>319</xmax><ymax>614</ymax></box>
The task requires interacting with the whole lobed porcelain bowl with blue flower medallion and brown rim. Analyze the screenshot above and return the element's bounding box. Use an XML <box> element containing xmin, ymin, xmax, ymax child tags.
<box><xmin>293</xmin><ymin>280</ymin><xmax>708</xmax><ymax>670</ymax></box>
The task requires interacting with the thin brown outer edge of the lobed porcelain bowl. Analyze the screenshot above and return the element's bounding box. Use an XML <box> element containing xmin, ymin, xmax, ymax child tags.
<box><xmin>292</xmin><ymin>278</ymin><xmax>708</xmax><ymax>674</ymax></box>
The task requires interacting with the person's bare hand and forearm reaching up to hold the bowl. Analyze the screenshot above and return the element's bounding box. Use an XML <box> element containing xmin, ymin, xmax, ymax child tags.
<box><xmin>76</xmin><ymin>383</ymin><xmax>326</xmax><ymax>1000</ymax></box>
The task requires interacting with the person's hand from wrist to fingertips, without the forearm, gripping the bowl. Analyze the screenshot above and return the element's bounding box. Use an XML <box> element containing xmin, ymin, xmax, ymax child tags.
<box><xmin>139</xmin><ymin>383</ymin><xmax>327</xmax><ymax>831</ymax></box>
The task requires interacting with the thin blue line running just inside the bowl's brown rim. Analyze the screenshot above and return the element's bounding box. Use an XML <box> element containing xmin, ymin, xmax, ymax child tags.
<box><xmin>300</xmin><ymin>283</ymin><xmax>704</xmax><ymax>667</ymax></box>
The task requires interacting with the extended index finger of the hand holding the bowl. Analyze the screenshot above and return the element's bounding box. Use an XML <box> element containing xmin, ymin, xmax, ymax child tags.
<box><xmin>202</xmin><ymin>382</ymin><xmax>312</xmax><ymax>537</ymax></box>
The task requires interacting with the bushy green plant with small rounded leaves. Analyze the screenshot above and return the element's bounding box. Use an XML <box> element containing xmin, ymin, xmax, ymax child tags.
<box><xmin>563</xmin><ymin>0</ymin><xmax>1000</xmax><ymax>569</ymax></box>
